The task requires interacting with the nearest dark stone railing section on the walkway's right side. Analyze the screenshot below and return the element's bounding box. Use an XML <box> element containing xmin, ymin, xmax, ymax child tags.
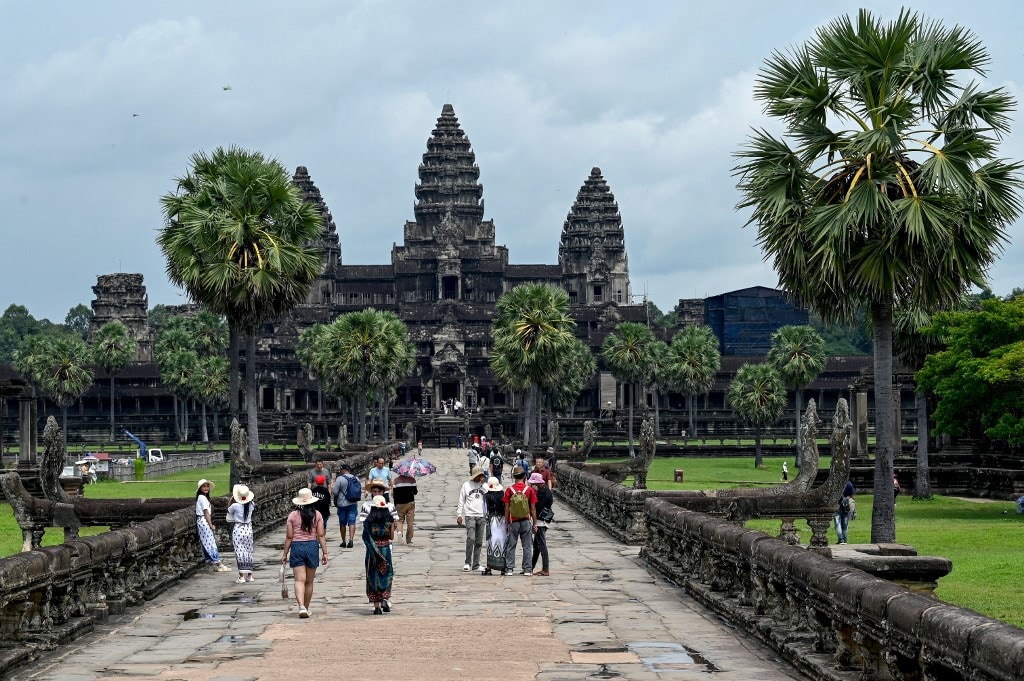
<box><xmin>641</xmin><ymin>499</ymin><xmax>1024</xmax><ymax>681</ymax></box>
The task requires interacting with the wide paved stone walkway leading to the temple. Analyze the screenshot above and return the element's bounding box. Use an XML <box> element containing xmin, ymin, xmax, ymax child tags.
<box><xmin>16</xmin><ymin>450</ymin><xmax>802</xmax><ymax>681</ymax></box>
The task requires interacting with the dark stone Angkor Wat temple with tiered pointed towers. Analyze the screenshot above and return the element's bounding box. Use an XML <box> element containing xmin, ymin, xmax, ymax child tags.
<box><xmin>0</xmin><ymin>104</ymin><xmax>888</xmax><ymax>440</ymax></box>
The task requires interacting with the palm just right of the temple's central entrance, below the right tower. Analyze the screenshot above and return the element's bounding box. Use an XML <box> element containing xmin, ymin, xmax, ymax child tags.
<box><xmin>490</xmin><ymin>284</ymin><xmax>575</xmax><ymax>448</ymax></box>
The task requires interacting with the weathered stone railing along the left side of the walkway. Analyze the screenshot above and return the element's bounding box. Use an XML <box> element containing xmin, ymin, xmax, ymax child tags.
<box><xmin>0</xmin><ymin>444</ymin><xmax>391</xmax><ymax>678</ymax></box>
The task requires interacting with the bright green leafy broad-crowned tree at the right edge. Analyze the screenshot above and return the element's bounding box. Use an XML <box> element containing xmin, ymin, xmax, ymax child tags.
<box><xmin>915</xmin><ymin>297</ymin><xmax>1024</xmax><ymax>453</ymax></box>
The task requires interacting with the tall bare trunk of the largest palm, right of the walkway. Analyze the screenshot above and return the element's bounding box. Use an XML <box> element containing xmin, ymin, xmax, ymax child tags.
<box><xmin>871</xmin><ymin>302</ymin><xmax>896</xmax><ymax>544</ymax></box>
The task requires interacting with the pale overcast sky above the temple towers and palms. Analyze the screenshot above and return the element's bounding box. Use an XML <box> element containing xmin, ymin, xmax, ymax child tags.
<box><xmin>0</xmin><ymin>0</ymin><xmax>1024</xmax><ymax>322</ymax></box>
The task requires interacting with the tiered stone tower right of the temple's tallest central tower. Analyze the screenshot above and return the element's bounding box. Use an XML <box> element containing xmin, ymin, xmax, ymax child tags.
<box><xmin>558</xmin><ymin>168</ymin><xmax>631</xmax><ymax>305</ymax></box>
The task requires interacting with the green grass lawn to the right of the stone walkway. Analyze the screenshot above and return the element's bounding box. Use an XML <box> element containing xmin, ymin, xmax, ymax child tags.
<box><xmin>647</xmin><ymin>458</ymin><xmax>1024</xmax><ymax>627</ymax></box>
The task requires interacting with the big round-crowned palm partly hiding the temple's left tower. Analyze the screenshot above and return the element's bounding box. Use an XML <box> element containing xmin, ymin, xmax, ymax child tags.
<box><xmin>157</xmin><ymin>147</ymin><xmax>324</xmax><ymax>461</ymax></box>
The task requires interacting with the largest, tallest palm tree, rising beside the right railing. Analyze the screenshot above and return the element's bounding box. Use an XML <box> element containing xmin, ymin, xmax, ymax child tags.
<box><xmin>736</xmin><ymin>9</ymin><xmax>1021</xmax><ymax>543</ymax></box>
